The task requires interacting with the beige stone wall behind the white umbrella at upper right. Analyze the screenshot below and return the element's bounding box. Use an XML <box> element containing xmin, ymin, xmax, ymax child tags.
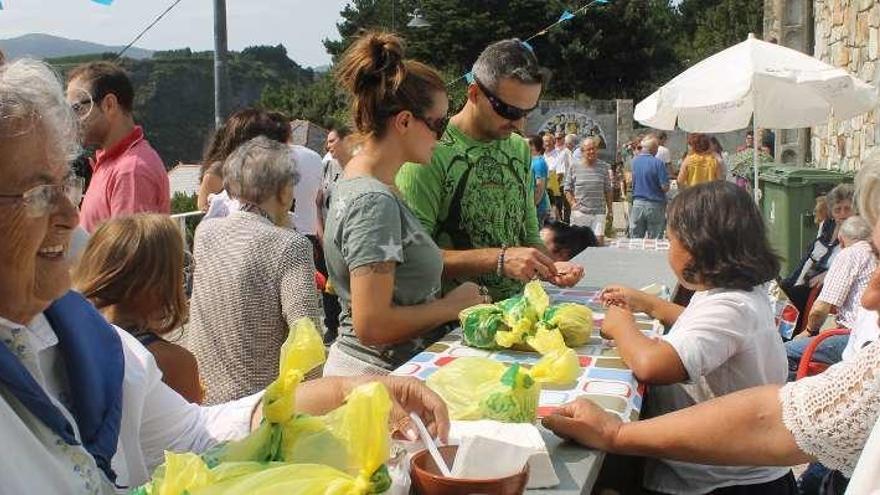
<box><xmin>811</xmin><ymin>0</ymin><xmax>880</xmax><ymax>170</ymax></box>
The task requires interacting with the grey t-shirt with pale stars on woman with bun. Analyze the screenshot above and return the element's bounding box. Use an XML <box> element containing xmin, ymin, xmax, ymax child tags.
<box><xmin>324</xmin><ymin>176</ymin><xmax>449</xmax><ymax>370</ymax></box>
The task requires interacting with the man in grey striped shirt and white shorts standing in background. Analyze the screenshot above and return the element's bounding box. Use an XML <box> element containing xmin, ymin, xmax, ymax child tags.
<box><xmin>564</xmin><ymin>137</ymin><xmax>614</xmax><ymax>246</ymax></box>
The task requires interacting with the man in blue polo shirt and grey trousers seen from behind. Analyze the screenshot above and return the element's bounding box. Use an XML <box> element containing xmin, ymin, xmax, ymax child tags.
<box><xmin>629</xmin><ymin>134</ymin><xmax>669</xmax><ymax>239</ymax></box>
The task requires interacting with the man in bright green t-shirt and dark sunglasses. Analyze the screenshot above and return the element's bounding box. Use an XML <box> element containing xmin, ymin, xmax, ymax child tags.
<box><xmin>397</xmin><ymin>39</ymin><xmax>583</xmax><ymax>300</ymax></box>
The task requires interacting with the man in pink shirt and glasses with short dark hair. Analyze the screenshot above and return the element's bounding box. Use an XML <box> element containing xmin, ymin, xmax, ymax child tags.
<box><xmin>67</xmin><ymin>61</ymin><xmax>171</xmax><ymax>233</ymax></box>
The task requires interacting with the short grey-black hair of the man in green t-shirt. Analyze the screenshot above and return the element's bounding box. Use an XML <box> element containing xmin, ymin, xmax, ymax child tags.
<box><xmin>472</xmin><ymin>38</ymin><xmax>544</xmax><ymax>91</ymax></box>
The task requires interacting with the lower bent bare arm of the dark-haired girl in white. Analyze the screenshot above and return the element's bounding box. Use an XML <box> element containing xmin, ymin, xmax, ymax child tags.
<box><xmin>602</xmin><ymin>306</ymin><xmax>688</xmax><ymax>385</ymax></box>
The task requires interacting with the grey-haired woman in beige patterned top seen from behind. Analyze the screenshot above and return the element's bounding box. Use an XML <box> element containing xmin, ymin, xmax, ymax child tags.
<box><xmin>184</xmin><ymin>136</ymin><xmax>320</xmax><ymax>404</ymax></box>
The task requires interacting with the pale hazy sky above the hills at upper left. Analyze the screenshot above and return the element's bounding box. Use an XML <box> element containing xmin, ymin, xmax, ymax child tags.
<box><xmin>0</xmin><ymin>0</ymin><xmax>348</xmax><ymax>67</ymax></box>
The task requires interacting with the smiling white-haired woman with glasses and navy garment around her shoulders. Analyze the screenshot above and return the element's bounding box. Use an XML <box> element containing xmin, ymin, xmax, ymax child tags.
<box><xmin>0</xmin><ymin>59</ymin><xmax>447</xmax><ymax>494</ymax></box>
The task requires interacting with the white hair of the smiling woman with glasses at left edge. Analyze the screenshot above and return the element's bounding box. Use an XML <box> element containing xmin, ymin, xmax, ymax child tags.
<box><xmin>0</xmin><ymin>58</ymin><xmax>81</xmax><ymax>162</ymax></box>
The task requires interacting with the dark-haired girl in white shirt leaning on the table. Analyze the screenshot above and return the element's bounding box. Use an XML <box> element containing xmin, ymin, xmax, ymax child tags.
<box><xmin>602</xmin><ymin>181</ymin><xmax>796</xmax><ymax>494</ymax></box>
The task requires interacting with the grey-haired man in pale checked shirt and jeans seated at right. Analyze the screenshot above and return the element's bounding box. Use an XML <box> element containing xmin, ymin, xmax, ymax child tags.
<box><xmin>785</xmin><ymin>216</ymin><xmax>877</xmax><ymax>380</ymax></box>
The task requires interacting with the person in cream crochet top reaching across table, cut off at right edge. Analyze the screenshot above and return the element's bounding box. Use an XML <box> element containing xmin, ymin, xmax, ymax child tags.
<box><xmin>544</xmin><ymin>153</ymin><xmax>880</xmax><ymax>494</ymax></box>
